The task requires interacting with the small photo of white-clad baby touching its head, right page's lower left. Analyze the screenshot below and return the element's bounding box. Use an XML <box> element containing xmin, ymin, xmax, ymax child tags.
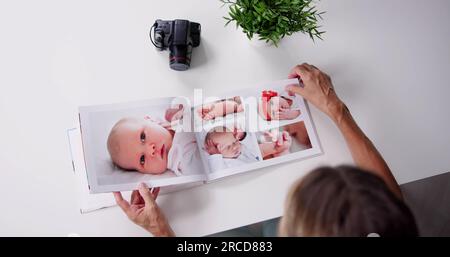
<box><xmin>201</xmin><ymin>122</ymin><xmax>262</xmax><ymax>172</ymax></box>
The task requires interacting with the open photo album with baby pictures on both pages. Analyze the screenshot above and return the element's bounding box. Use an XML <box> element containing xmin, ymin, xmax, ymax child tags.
<box><xmin>69</xmin><ymin>79</ymin><xmax>322</xmax><ymax>194</ymax></box>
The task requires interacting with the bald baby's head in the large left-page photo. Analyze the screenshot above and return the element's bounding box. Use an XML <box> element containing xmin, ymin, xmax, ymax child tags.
<box><xmin>107</xmin><ymin>118</ymin><xmax>173</xmax><ymax>174</ymax></box>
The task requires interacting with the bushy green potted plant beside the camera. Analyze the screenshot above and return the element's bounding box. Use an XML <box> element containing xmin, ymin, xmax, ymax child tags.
<box><xmin>221</xmin><ymin>0</ymin><xmax>325</xmax><ymax>46</ymax></box>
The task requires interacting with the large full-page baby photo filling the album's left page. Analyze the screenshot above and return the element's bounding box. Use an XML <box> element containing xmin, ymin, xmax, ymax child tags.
<box><xmin>81</xmin><ymin>98</ymin><xmax>204</xmax><ymax>191</ymax></box>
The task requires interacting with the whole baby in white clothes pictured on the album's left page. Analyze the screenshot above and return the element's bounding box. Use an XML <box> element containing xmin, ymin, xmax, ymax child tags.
<box><xmin>107</xmin><ymin>104</ymin><xmax>201</xmax><ymax>176</ymax></box>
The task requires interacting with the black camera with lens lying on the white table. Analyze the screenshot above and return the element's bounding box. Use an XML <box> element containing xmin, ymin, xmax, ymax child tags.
<box><xmin>150</xmin><ymin>19</ymin><xmax>201</xmax><ymax>71</ymax></box>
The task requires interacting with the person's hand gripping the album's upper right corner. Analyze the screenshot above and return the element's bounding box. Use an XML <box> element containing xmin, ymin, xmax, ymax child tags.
<box><xmin>286</xmin><ymin>63</ymin><xmax>343</xmax><ymax>118</ymax></box>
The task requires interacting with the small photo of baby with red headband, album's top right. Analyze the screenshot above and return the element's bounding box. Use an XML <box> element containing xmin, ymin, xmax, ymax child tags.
<box><xmin>258</xmin><ymin>90</ymin><xmax>300</xmax><ymax>121</ymax></box>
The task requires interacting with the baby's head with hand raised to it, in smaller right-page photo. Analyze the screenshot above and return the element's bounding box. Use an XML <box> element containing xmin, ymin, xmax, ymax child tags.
<box><xmin>205</xmin><ymin>127</ymin><xmax>246</xmax><ymax>158</ymax></box>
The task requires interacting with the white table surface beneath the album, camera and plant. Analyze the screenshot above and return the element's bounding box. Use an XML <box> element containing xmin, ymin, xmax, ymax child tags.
<box><xmin>0</xmin><ymin>0</ymin><xmax>450</xmax><ymax>236</ymax></box>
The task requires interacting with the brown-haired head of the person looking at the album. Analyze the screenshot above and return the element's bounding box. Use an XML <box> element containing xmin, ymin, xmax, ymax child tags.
<box><xmin>279</xmin><ymin>166</ymin><xmax>418</xmax><ymax>237</ymax></box>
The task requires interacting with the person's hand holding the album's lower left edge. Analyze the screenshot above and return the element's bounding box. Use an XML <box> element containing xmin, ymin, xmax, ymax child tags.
<box><xmin>114</xmin><ymin>183</ymin><xmax>174</xmax><ymax>236</ymax></box>
